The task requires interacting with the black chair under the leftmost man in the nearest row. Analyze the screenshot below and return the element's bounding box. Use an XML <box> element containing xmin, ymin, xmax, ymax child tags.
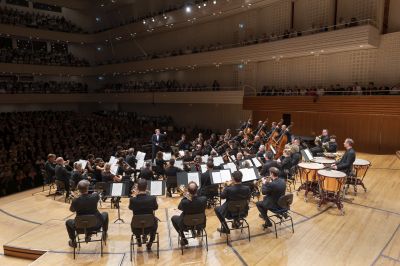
<box><xmin>74</xmin><ymin>215</ymin><xmax>106</xmax><ymax>259</ymax></box>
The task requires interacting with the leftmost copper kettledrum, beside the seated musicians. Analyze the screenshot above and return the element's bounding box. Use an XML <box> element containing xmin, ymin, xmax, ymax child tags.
<box><xmin>297</xmin><ymin>163</ymin><xmax>324</xmax><ymax>201</ymax></box>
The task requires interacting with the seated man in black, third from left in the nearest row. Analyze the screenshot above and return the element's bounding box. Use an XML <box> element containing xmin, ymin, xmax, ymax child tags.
<box><xmin>171</xmin><ymin>182</ymin><xmax>207</xmax><ymax>246</ymax></box>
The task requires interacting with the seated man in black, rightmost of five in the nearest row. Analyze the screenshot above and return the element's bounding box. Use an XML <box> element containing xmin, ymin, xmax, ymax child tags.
<box><xmin>256</xmin><ymin>167</ymin><xmax>286</xmax><ymax>228</ymax></box>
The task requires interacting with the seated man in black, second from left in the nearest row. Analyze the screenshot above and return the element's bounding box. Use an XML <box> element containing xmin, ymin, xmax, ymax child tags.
<box><xmin>129</xmin><ymin>178</ymin><xmax>158</xmax><ymax>250</ymax></box>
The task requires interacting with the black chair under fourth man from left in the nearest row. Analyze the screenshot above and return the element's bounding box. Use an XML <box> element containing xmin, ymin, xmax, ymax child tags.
<box><xmin>220</xmin><ymin>200</ymin><xmax>251</xmax><ymax>244</ymax></box>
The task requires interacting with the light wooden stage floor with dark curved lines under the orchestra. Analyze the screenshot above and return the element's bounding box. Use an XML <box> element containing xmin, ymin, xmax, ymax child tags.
<box><xmin>0</xmin><ymin>154</ymin><xmax>400</xmax><ymax>266</ymax></box>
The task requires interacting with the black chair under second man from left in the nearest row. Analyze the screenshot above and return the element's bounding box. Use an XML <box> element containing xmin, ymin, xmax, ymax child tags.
<box><xmin>130</xmin><ymin>214</ymin><xmax>160</xmax><ymax>261</ymax></box>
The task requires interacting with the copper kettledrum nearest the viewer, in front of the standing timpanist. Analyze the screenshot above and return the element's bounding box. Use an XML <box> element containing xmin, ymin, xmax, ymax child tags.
<box><xmin>318</xmin><ymin>170</ymin><xmax>346</xmax><ymax>215</ymax></box>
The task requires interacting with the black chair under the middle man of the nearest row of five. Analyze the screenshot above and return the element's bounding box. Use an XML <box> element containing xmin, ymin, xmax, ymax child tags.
<box><xmin>178</xmin><ymin>213</ymin><xmax>208</xmax><ymax>255</ymax></box>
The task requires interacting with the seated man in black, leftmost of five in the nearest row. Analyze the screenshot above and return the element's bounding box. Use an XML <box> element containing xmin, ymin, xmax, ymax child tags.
<box><xmin>65</xmin><ymin>180</ymin><xmax>108</xmax><ymax>247</ymax></box>
